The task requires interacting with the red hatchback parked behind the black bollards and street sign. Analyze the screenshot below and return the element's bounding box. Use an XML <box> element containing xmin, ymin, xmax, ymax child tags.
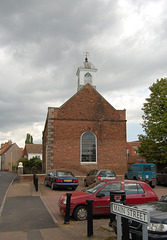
<box><xmin>58</xmin><ymin>180</ymin><xmax>158</xmax><ymax>221</ymax></box>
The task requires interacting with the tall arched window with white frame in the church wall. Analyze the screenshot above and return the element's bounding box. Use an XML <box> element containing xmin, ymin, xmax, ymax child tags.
<box><xmin>81</xmin><ymin>132</ymin><xmax>97</xmax><ymax>163</ymax></box>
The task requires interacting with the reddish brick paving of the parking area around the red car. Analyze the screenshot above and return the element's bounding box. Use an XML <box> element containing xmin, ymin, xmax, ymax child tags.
<box><xmin>39</xmin><ymin>183</ymin><xmax>167</xmax><ymax>240</ymax></box>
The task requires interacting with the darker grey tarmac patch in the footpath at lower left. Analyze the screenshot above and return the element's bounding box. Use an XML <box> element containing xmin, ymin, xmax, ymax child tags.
<box><xmin>0</xmin><ymin>196</ymin><xmax>57</xmax><ymax>232</ymax></box>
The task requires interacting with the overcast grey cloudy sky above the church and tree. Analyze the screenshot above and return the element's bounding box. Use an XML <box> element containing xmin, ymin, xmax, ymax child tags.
<box><xmin>0</xmin><ymin>0</ymin><xmax>167</xmax><ymax>147</ymax></box>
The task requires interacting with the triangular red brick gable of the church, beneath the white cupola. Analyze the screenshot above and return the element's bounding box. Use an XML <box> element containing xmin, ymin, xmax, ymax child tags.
<box><xmin>57</xmin><ymin>84</ymin><xmax>125</xmax><ymax>121</ymax></box>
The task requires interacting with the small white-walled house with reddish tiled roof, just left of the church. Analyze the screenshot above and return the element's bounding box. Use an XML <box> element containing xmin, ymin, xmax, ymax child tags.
<box><xmin>23</xmin><ymin>144</ymin><xmax>42</xmax><ymax>160</ymax></box>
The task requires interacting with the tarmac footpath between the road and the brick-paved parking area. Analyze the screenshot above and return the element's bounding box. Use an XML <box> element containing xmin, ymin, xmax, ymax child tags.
<box><xmin>0</xmin><ymin>176</ymin><xmax>64</xmax><ymax>240</ymax></box>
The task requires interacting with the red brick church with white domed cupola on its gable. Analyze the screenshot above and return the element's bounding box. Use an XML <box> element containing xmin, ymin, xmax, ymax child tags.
<box><xmin>43</xmin><ymin>57</ymin><xmax>127</xmax><ymax>175</ymax></box>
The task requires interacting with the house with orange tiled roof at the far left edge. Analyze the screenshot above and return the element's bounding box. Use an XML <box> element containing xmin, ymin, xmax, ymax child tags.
<box><xmin>0</xmin><ymin>141</ymin><xmax>23</xmax><ymax>172</ymax></box>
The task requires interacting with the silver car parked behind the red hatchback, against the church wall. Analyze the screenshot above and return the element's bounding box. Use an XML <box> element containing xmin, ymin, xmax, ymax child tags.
<box><xmin>84</xmin><ymin>169</ymin><xmax>116</xmax><ymax>187</ymax></box>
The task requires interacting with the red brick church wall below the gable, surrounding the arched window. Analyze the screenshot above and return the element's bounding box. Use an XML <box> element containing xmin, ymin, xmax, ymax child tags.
<box><xmin>50</xmin><ymin>120</ymin><xmax>127</xmax><ymax>175</ymax></box>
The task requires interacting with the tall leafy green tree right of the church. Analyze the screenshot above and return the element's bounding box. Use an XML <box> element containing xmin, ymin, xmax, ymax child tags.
<box><xmin>138</xmin><ymin>78</ymin><xmax>167</xmax><ymax>163</ymax></box>
